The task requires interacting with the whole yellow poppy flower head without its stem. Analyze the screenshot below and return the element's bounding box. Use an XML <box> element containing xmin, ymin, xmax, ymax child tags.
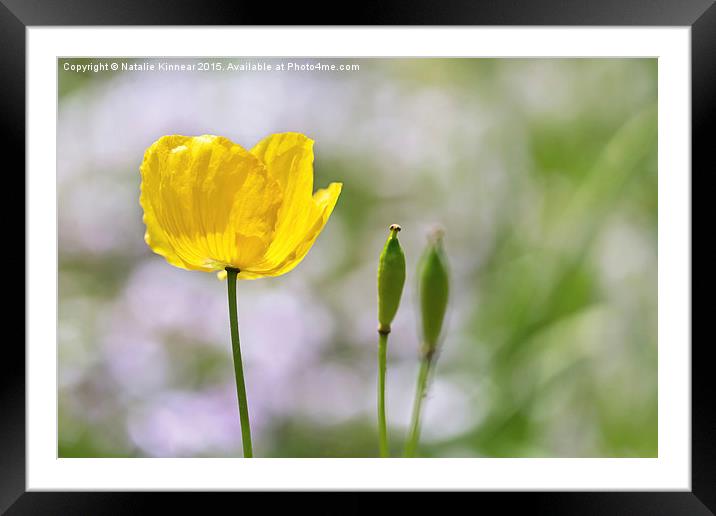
<box><xmin>139</xmin><ymin>133</ymin><xmax>342</xmax><ymax>279</ymax></box>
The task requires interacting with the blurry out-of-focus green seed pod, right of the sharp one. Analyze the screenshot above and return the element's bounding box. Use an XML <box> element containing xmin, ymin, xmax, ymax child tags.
<box><xmin>418</xmin><ymin>230</ymin><xmax>449</xmax><ymax>355</ymax></box>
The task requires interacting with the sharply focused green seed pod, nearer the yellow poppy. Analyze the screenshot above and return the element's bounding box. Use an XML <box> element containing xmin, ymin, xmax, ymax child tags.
<box><xmin>378</xmin><ymin>224</ymin><xmax>405</xmax><ymax>333</ymax></box>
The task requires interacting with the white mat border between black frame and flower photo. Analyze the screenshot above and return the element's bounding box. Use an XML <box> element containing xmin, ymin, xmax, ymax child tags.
<box><xmin>27</xmin><ymin>27</ymin><xmax>691</xmax><ymax>490</ymax></box>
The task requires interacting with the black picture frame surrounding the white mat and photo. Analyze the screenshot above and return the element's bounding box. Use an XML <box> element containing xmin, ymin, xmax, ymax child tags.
<box><xmin>0</xmin><ymin>0</ymin><xmax>716</xmax><ymax>515</ymax></box>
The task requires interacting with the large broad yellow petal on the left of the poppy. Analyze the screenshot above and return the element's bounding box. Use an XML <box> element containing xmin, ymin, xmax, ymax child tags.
<box><xmin>140</xmin><ymin>135</ymin><xmax>282</xmax><ymax>271</ymax></box>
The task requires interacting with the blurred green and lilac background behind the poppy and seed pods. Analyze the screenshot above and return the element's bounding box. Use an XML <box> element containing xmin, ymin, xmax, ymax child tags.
<box><xmin>57</xmin><ymin>59</ymin><xmax>657</xmax><ymax>457</ymax></box>
